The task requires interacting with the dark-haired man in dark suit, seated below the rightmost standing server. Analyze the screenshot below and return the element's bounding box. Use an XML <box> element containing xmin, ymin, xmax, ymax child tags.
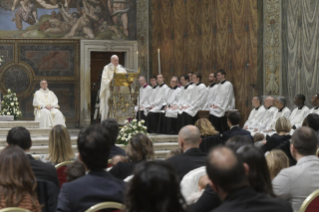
<box><xmin>221</xmin><ymin>111</ymin><xmax>253</xmax><ymax>141</ymax></box>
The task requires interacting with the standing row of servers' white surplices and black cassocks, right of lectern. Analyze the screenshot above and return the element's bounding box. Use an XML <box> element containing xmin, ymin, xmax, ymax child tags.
<box><xmin>135</xmin><ymin>74</ymin><xmax>235</xmax><ymax>134</ymax></box>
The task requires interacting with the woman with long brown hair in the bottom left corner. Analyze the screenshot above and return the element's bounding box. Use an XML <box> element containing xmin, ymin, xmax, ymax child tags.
<box><xmin>0</xmin><ymin>145</ymin><xmax>41</xmax><ymax>212</ymax></box>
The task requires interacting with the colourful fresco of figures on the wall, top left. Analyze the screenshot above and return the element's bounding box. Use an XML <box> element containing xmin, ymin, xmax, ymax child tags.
<box><xmin>0</xmin><ymin>0</ymin><xmax>136</xmax><ymax>40</ymax></box>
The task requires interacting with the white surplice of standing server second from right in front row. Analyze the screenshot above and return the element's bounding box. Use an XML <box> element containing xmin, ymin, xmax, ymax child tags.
<box><xmin>183</xmin><ymin>83</ymin><xmax>208</xmax><ymax>117</ymax></box>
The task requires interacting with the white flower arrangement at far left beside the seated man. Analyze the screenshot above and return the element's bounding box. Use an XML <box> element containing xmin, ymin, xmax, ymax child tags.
<box><xmin>0</xmin><ymin>89</ymin><xmax>22</xmax><ymax>120</ymax></box>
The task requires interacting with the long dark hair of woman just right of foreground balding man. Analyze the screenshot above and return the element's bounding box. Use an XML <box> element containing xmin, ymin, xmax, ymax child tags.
<box><xmin>236</xmin><ymin>145</ymin><xmax>274</xmax><ymax>196</ymax></box>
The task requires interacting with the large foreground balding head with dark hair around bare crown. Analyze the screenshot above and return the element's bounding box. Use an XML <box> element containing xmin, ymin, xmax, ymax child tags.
<box><xmin>206</xmin><ymin>146</ymin><xmax>248</xmax><ymax>193</ymax></box>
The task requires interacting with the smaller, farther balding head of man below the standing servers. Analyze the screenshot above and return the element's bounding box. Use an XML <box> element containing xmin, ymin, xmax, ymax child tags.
<box><xmin>178</xmin><ymin>125</ymin><xmax>201</xmax><ymax>147</ymax></box>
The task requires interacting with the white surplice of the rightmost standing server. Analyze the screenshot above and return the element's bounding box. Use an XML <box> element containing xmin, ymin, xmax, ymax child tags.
<box><xmin>210</xmin><ymin>80</ymin><xmax>235</xmax><ymax>118</ymax></box>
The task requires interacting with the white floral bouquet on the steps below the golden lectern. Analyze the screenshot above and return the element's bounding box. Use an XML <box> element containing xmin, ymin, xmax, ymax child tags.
<box><xmin>116</xmin><ymin>119</ymin><xmax>148</xmax><ymax>145</ymax></box>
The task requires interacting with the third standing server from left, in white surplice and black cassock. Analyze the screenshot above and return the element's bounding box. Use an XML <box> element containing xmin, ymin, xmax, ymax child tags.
<box><xmin>146</xmin><ymin>74</ymin><xmax>169</xmax><ymax>133</ymax></box>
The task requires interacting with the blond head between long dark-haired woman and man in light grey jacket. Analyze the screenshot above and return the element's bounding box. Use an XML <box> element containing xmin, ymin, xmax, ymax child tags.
<box><xmin>266</xmin><ymin>149</ymin><xmax>289</xmax><ymax>180</ymax></box>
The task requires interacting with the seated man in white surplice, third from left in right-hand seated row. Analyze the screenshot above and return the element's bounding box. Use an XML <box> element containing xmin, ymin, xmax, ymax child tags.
<box><xmin>266</xmin><ymin>96</ymin><xmax>291</xmax><ymax>132</ymax></box>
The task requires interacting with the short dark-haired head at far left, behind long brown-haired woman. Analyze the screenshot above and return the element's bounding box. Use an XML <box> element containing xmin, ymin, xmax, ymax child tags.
<box><xmin>7</xmin><ymin>127</ymin><xmax>31</xmax><ymax>150</ymax></box>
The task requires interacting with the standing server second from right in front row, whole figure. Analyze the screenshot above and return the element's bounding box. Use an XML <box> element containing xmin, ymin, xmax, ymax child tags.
<box><xmin>177</xmin><ymin>72</ymin><xmax>209</xmax><ymax>129</ymax></box>
